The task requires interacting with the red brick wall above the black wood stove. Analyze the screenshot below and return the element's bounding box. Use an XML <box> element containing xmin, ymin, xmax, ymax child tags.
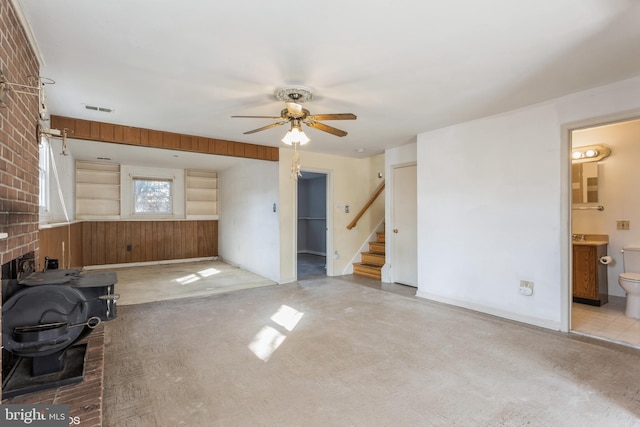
<box><xmin>0</xmin><ymin>0</ymin><xmax>39</xmax><ymax>264</ymax></box>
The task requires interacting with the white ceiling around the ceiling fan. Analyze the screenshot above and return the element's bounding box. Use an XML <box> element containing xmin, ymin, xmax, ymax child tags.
<box><xmin>16</xmin><ymin>0</ymin><xmax>640</xmax><ymax>165</ymax></box>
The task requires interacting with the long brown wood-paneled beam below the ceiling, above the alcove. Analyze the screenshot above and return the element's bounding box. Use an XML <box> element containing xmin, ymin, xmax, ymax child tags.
<box><xmin>51</xmin><ymin>116</ymin><xmax>279</xmax><ymax>161</ymax></box>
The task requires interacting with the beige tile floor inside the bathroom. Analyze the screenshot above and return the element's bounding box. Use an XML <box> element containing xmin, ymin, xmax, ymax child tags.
<box><xmin>571</xmin><ymin>298</ymin><xmax>640</xmax><ymax>348</ymax></box>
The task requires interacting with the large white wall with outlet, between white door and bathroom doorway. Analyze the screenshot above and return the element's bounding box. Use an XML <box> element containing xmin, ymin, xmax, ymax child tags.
<box><xmin>418</xmin><ymin>78</ymin><xmax>640</xmax><ymax>330</ymax></box>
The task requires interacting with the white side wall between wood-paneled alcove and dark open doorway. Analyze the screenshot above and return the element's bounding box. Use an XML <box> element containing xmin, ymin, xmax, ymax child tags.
<box><xmin>218</xmin><ymin>160</ymin><xmax>280</xmax><ymax>282</ymax></box>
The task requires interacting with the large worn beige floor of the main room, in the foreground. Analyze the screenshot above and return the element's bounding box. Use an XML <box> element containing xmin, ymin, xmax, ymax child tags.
<box><xmin>104</xmin><ymin>276</ymin><xmax>640</xmax><ymax>426</ymax></box>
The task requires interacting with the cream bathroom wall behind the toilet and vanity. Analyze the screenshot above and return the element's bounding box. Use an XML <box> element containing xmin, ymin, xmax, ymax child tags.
<box><xmin>572</xmin><ymin>120</ymin><xmax>640</xmax><ymax>297</ymax></box>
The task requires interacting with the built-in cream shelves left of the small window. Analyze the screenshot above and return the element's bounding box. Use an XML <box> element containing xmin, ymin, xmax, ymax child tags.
<box><xmin>76</xmin><ymin>160</ymin><xmax>120</xmax><ymax>219</ymax></box>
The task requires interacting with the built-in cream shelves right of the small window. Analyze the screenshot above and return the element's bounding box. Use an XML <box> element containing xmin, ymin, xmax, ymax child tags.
<box><xmin>185</xmin><ymin>169</ymin><xmax>218</xmax><ymax>218</ymax></box>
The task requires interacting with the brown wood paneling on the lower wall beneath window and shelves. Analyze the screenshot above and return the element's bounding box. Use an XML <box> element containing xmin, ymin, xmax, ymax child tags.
<box><xmin>40</xmin><ymin>220</ymin><xmax>218</xmax><ymax>268</ymax></box>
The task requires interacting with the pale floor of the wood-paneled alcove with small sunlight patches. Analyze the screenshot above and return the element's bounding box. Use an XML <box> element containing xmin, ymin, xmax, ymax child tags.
<box><xmin>88</xmin><ymin>261</ymin><xmax>276</xmax><ymax>306</ymax></box>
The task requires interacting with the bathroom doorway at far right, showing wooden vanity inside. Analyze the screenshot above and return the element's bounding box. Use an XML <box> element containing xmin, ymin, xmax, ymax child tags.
<box><xmin>569</xmin><ymin>118</ymin><xmax>640</xmax><ymax>348</ymax></box>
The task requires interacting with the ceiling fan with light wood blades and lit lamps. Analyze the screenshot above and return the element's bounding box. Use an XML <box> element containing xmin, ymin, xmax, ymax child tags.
<box><xmin>231</xmin><ymin>86</ymin><xmax>357</xmax><ymax>140</ymax></box>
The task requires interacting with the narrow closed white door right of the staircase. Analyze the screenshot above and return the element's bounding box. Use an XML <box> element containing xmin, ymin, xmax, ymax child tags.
<box><xmin>391</xmin><ymin>165</ymin><xmax>418</xmax><ymax>287</ymax></box>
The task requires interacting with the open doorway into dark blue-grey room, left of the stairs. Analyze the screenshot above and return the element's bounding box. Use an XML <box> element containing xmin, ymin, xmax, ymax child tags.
<box><xmin>296</xmin><ymin>171</ymin><xmax>328</xmax><ymax>280</ymax></box>
